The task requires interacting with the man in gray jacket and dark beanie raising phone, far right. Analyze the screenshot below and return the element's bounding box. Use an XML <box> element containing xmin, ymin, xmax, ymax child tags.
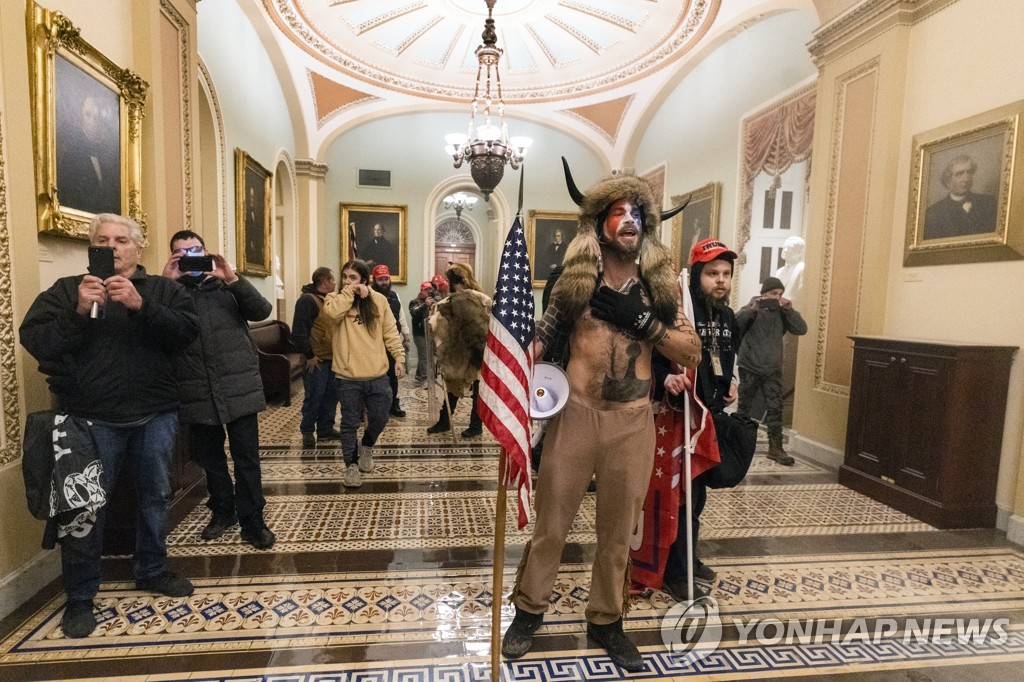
<box><xmin>736</xmin><ymin>278</ymin><xmax>807</xmax><ymax>467</ymax></box>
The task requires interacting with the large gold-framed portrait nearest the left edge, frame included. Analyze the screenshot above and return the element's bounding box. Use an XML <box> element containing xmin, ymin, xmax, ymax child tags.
<box><xmin>26</xmin><ymin>3</ymin><xmax>150</xmax><ymax>240</ymax></box>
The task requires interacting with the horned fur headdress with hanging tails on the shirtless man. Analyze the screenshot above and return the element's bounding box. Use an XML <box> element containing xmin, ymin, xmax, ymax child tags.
<box><xmin>558</xmin><ymin>157</ymin><xmax>689</xmax><ymax>325</ymax></box>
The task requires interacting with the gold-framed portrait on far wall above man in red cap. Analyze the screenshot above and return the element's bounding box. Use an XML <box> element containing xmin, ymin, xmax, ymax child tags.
<box><xmin>338</xmin><ymin>204</ymin><xmax>409</xmax><ymax>285</ymax></box>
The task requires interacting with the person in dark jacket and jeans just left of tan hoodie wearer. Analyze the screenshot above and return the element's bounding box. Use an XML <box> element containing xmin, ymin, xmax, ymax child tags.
<box><xmin>292</xmin><ymin>267</ymin><xmax>341</xmax><ymax>447</ymax></box>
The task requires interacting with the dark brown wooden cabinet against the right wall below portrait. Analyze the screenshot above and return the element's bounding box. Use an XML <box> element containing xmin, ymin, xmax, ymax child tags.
<box><xmin>839</xmin><ymin>336</ymin><xmax>1017</xmax><ymax>528</ymax></box>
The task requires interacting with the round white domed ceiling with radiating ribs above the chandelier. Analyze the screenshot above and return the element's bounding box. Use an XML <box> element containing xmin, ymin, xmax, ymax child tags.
<box><xmin>264</xmin><ymin>0</ymin><xmax>720</xmax><ymax>103</ymax></box>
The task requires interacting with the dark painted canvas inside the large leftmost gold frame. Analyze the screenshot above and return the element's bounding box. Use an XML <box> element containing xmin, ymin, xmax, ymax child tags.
<box><xmin>54</xmin><ymin>54</ymin><xmax>123</xmax><ymax>213</ymax></box>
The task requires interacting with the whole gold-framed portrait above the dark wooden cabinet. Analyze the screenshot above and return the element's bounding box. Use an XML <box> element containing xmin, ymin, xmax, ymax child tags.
<box><xmin>903</xmin><ymin>101</ymin><xmax>1024</xmax><ymax>266</ymax></box>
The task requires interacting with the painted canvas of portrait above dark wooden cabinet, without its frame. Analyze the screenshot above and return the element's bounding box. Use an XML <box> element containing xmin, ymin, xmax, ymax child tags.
<box><xmin>921</xmin><ymin>134</ymin><xmax>1004</xmax><ymax>240</ymax></box>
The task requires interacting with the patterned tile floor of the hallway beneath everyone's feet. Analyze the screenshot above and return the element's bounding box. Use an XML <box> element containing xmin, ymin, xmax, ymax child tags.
<box><xmin>0</xmin><ymin>374</ymin><xmax>1024</xmax><ymax>682</ymax></box>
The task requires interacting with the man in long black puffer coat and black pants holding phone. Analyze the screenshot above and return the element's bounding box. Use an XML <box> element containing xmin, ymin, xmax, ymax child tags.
<box><xmin>164</xmin><ymin>229</ymin><xmax>275</xmax><ymax>549</ymax></box>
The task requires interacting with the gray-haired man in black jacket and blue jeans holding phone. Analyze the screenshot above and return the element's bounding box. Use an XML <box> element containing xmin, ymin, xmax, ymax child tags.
<box><xmin>19</xmin><ymin>213</ymin><xmax>199</xmax><ymax>637</ymax></box>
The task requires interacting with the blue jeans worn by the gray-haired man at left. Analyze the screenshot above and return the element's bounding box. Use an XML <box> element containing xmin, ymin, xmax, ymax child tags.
<box><xmin>60</xmin><ymin>412</ymin><xmax>178</xmax><ymax>601</ymax></box>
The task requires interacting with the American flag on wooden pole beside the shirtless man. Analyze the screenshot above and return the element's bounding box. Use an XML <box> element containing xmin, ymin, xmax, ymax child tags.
<box><xmin>478</xmin><ymin>216</ymin><xmax>534</xmax><ymax>529</ymax></box>
